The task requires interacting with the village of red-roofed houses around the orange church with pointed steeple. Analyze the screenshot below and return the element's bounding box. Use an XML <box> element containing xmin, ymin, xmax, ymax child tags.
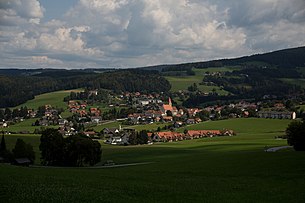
<box><xmin>0</xmin><ymin>90</ymin><xmax>297</xmax><ymax>145</ymax></box>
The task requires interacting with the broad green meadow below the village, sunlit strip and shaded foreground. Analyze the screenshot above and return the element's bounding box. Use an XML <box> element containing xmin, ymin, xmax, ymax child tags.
<box><xmin>0</xmin><ymin>119</ymin><xmax>305</xmax><ymax>202</ymax></box>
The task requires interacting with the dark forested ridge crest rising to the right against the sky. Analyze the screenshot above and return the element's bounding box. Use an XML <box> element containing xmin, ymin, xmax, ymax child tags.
<box><xmin>143</xmin><ymin>47</ymin><xmax>305</xmax><ymax>71</ymax></box>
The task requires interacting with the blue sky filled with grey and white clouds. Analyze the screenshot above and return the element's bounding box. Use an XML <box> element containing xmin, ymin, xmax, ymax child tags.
<box><xmin>0</xmin><ymin>0</ymin><xmax>305</xmax><ymax>69</ymax></box>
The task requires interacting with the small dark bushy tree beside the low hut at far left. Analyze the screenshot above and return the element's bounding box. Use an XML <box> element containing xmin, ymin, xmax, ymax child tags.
<box><xmin>12</xmin><ymin>138</ymin><xmax>35</xmax><ymax>163</ymax></box>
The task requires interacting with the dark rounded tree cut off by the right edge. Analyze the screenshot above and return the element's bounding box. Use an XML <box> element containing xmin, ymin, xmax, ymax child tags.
<box><xmin>286</xmin><ymin>121</ymin><xmax>305</xmax><ymax>151</ymax></box>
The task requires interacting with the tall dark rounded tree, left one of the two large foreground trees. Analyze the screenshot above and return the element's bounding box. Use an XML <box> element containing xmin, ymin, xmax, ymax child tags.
<box><xmin>39</xmin><ymin>128</ymin><xmax>64</xmax><ymax>166</ymax></box>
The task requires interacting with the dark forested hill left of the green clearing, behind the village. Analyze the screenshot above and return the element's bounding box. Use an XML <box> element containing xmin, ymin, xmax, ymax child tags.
<box><xmin>0</xmin><ymin>70</ymin><xmax>171</xmax><ymax>108</ymax></box>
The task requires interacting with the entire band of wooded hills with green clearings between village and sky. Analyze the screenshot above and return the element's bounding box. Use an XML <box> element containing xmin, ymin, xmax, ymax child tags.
<box><xmin>0</xmin><ymin>47</ymin><xmax>305</xmax><ymax>108</ymax></box>
